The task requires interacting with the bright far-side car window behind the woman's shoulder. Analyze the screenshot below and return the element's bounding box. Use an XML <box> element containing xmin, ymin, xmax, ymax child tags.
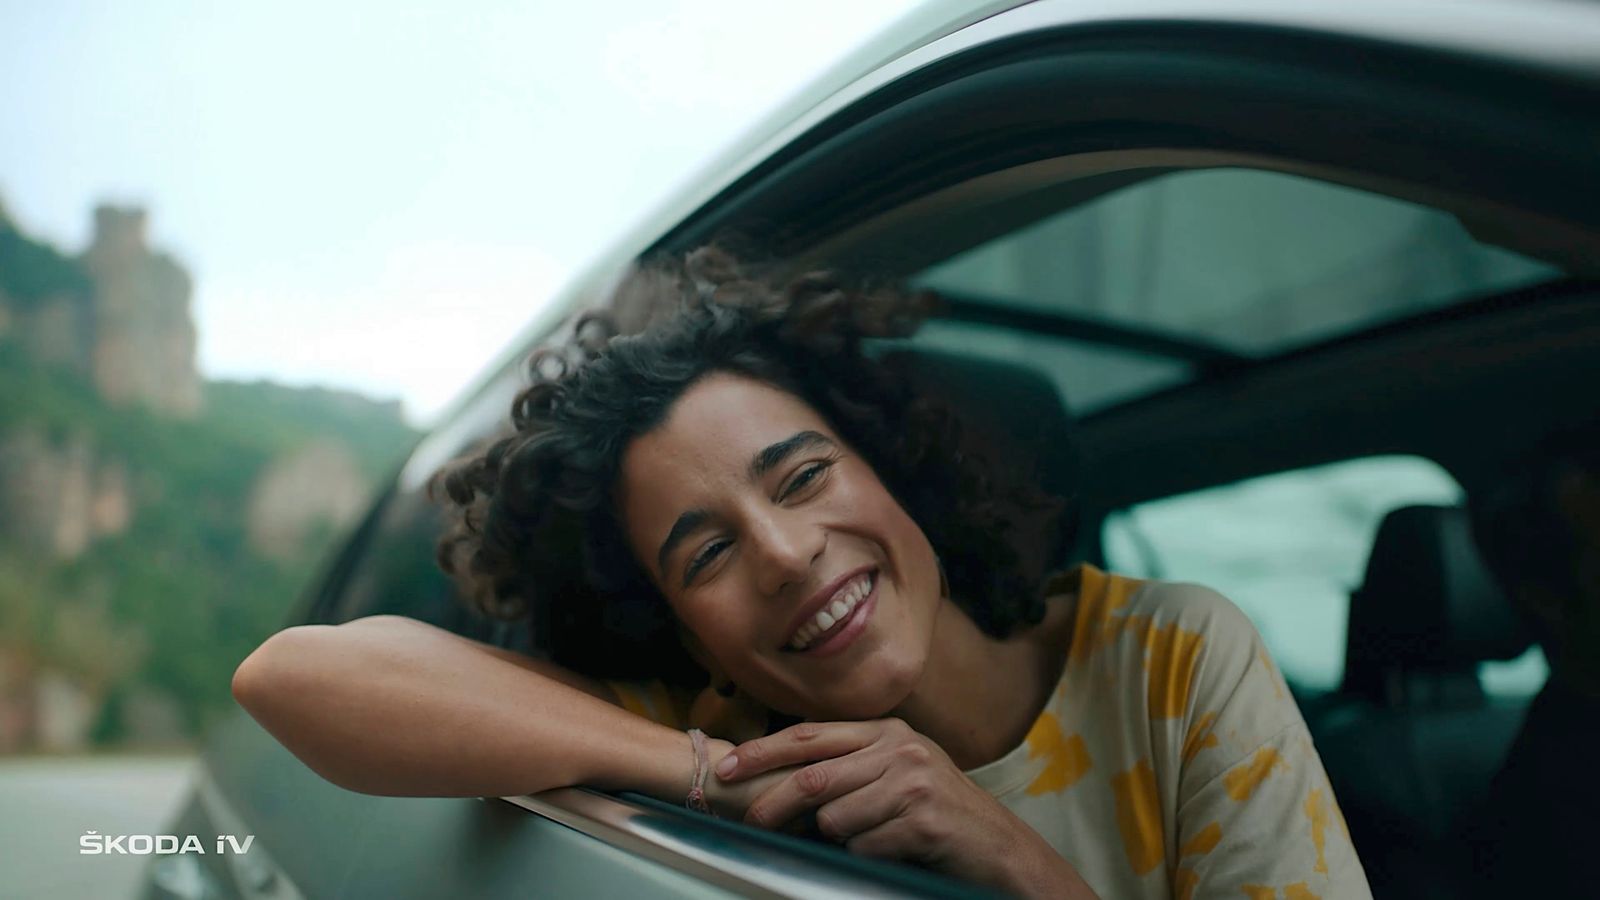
<box><xmin>1102</xmin><ymin>456</ymin><xmax>1546</xmax><ymax>695</ymax></box>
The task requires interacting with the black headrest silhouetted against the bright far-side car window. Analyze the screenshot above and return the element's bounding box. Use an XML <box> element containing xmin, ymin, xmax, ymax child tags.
<box><xmin>1344</xmin><ymin>506</ymin><xmax>1531</xmax><ymax>692</ymax></box>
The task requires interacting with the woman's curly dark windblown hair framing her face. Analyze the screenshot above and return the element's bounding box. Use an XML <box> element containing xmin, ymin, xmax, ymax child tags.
<box><xmin>432</xmin><ymin>247</ymin><xmax>1062</xmax><ymax>685</ymax></box>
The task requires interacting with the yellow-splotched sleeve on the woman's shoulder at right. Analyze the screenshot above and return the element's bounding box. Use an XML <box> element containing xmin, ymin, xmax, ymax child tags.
<box><xmin>1173</xmin><ymin>586</ymin><xmax>1371</xmax><ymax>900</ymax></box>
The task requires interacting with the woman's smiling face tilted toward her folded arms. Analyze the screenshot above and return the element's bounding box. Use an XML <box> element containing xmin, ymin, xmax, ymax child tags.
<box><xmin>618</xmin><ymin>373</ymin><xmax>941</xmax><ymax>719</ymax></box>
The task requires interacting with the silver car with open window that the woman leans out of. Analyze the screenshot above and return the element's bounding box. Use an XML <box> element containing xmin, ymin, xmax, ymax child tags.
<box><xmin>146</xmin><ymin>0</ymin><xmax>1600</xmax><ymax>900</ymax></box>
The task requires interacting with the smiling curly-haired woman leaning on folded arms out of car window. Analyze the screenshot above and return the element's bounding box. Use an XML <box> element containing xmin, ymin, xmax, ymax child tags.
<box><xmin>235</xmin><ymin>248</ymin><xmax>1368</xmax><ymax>898</ymax></box>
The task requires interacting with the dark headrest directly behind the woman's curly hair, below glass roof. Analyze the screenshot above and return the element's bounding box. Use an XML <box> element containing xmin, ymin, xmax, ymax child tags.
<box><xmin>880</xmin><ymin>346</ymin><xmax>1080</xmax><ymax>570</ymax></box>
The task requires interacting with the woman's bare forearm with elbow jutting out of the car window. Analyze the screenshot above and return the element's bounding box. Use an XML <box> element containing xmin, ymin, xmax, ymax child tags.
<box><xmin>234</xmin><ymin>620</ymin><xmax>693</xmax><ymax>798</ymax></box>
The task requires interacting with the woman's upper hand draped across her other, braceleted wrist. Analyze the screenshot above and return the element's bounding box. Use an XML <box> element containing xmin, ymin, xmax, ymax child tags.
<box><xmin>714</xmin><ymin>719</ymin><xmax>1093</xmax><ymax>897</ymax></box>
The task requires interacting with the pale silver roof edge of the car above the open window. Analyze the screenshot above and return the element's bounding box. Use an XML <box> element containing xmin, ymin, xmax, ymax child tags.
<box><xmin>406</xmin><ymin>0</ymin><xmax>1600</xmax><ymax>490</ymax></box>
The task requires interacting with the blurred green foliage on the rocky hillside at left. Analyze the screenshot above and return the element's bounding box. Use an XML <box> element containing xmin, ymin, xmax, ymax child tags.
<box><xmin>0</xmin><ymin>221</ymin><xmax>416</xmax><ymax>740</ymax></box>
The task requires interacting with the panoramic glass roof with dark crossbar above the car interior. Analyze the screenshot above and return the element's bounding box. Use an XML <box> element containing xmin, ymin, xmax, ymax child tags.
<box><xmin>910</xmin><ymin>168</ymin><xmax>1563</xmax><ymax>413</ymax></box>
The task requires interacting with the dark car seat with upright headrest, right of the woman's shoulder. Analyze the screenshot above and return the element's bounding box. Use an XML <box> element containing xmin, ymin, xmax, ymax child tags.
<box><xmin>1312</xmin><ymin>506</ymin><xmax>1531</xmax><ymax>897</ymax></box>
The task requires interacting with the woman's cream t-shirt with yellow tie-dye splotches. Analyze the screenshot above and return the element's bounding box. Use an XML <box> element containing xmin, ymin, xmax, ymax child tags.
<box><xmin>613</xmin><ymin>565</ymin><xmax>1371</xmax><ymax>900</ymax></box>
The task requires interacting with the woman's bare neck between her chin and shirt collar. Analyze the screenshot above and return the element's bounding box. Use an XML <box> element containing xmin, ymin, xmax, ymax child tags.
<box><xmin>894</xmin><ymin>599</ymin><xmax>1059</xmax><ymax>769</ymax></box>
